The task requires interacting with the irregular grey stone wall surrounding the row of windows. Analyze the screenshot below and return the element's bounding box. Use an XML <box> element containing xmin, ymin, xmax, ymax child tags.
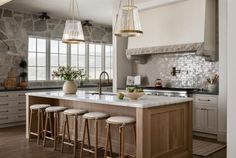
<box><xmin>0</xmin><ymin>8</ymin><xmax>112</xmax><ymax>86</ymax></box>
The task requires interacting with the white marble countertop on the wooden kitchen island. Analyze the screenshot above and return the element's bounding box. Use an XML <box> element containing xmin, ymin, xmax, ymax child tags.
<box><xmin>26</xmin><ymin>91</ymin><xmax>193</xmax><ymax>108</ymax></box>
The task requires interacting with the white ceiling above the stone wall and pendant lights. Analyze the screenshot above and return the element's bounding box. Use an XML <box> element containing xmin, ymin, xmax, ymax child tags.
<box><xmin>3</xmin><ymin>0</ymin><xmax>184</xmax><ymax>25</ymax></box>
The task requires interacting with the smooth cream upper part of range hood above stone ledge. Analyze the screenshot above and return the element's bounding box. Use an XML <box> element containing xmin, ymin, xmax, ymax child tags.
<box><xmin>128</xmin><ymin>0</ymin><xmax>205</xmax><ymax>48</ymax></box>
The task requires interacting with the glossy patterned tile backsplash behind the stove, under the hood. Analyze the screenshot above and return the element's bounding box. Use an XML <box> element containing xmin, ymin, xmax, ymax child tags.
<box><xmin>132</xmin><ymin>53</ymin><xmax>218</xmax><ymax>88</ymax></box>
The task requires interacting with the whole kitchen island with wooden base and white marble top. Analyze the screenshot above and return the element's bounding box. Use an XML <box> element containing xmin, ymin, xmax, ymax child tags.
<box><xmin>26</xmin><ymin>91</ymin><xmax>192</xmax><ymax>158</ymax></box>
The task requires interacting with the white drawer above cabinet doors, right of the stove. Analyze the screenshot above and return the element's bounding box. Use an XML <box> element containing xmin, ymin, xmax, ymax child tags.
<box><xmin>194</xmin><ymin>95</ymin><xmax>218</xmax><ymax>106</ymax></box>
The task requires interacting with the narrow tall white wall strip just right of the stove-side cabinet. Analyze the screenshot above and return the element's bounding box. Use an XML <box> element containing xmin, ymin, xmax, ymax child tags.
<box><xmin>217</xmin><ymin>0</ymin><xmax>227</xmax><ymax>142</ymax></box>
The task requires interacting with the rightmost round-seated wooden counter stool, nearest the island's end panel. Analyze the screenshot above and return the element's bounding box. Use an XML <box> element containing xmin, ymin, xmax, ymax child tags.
<box><xmin>104</xmin><ymin>116</ymin><xmax>136</xmax><ymax>158</ymax></box>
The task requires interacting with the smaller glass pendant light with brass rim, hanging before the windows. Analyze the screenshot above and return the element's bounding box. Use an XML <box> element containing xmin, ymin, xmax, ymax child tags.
<box><xmin>62</xmin><ymin>0</ymin><xmax>84</xmax><ymax>44</ymax></box>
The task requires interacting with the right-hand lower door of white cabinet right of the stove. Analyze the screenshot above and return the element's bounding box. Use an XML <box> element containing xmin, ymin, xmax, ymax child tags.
<box><xmin>205</xmin><ymin>107</ymin><xmax>218</xmax><ymax>134</ymax></box>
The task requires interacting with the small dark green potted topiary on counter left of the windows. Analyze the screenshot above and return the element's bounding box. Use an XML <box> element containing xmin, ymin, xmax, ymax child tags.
<box><xmin>19</xmin><ymin>59</ymin><xmax>28</xmax><ymax>89</ymax></box>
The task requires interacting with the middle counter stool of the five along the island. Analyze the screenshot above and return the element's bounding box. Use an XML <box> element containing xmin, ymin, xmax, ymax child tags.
<box><xmin>61</xmin><ymin>109</ymin><xmax>87</xmax><ymax>157</ymax></box>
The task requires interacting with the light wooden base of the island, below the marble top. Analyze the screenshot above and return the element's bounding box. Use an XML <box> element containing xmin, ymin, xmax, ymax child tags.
<box><xmin>26</xmin><ymin>95</ymin><xmax>192</xmax><ymax>158</ymax></box>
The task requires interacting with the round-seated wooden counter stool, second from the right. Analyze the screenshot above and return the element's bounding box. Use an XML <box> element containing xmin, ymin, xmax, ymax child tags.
<box><xmin>80</xmin><ymin>112</ymin><xmax>109</xmax><ymax>158</ymax></box>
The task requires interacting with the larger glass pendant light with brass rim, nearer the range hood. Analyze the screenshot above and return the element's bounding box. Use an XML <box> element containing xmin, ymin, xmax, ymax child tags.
<box><xmin>115</xmin><ymin>0</ymin><xmax>143</xmax><ymax>37</ymax></box>
